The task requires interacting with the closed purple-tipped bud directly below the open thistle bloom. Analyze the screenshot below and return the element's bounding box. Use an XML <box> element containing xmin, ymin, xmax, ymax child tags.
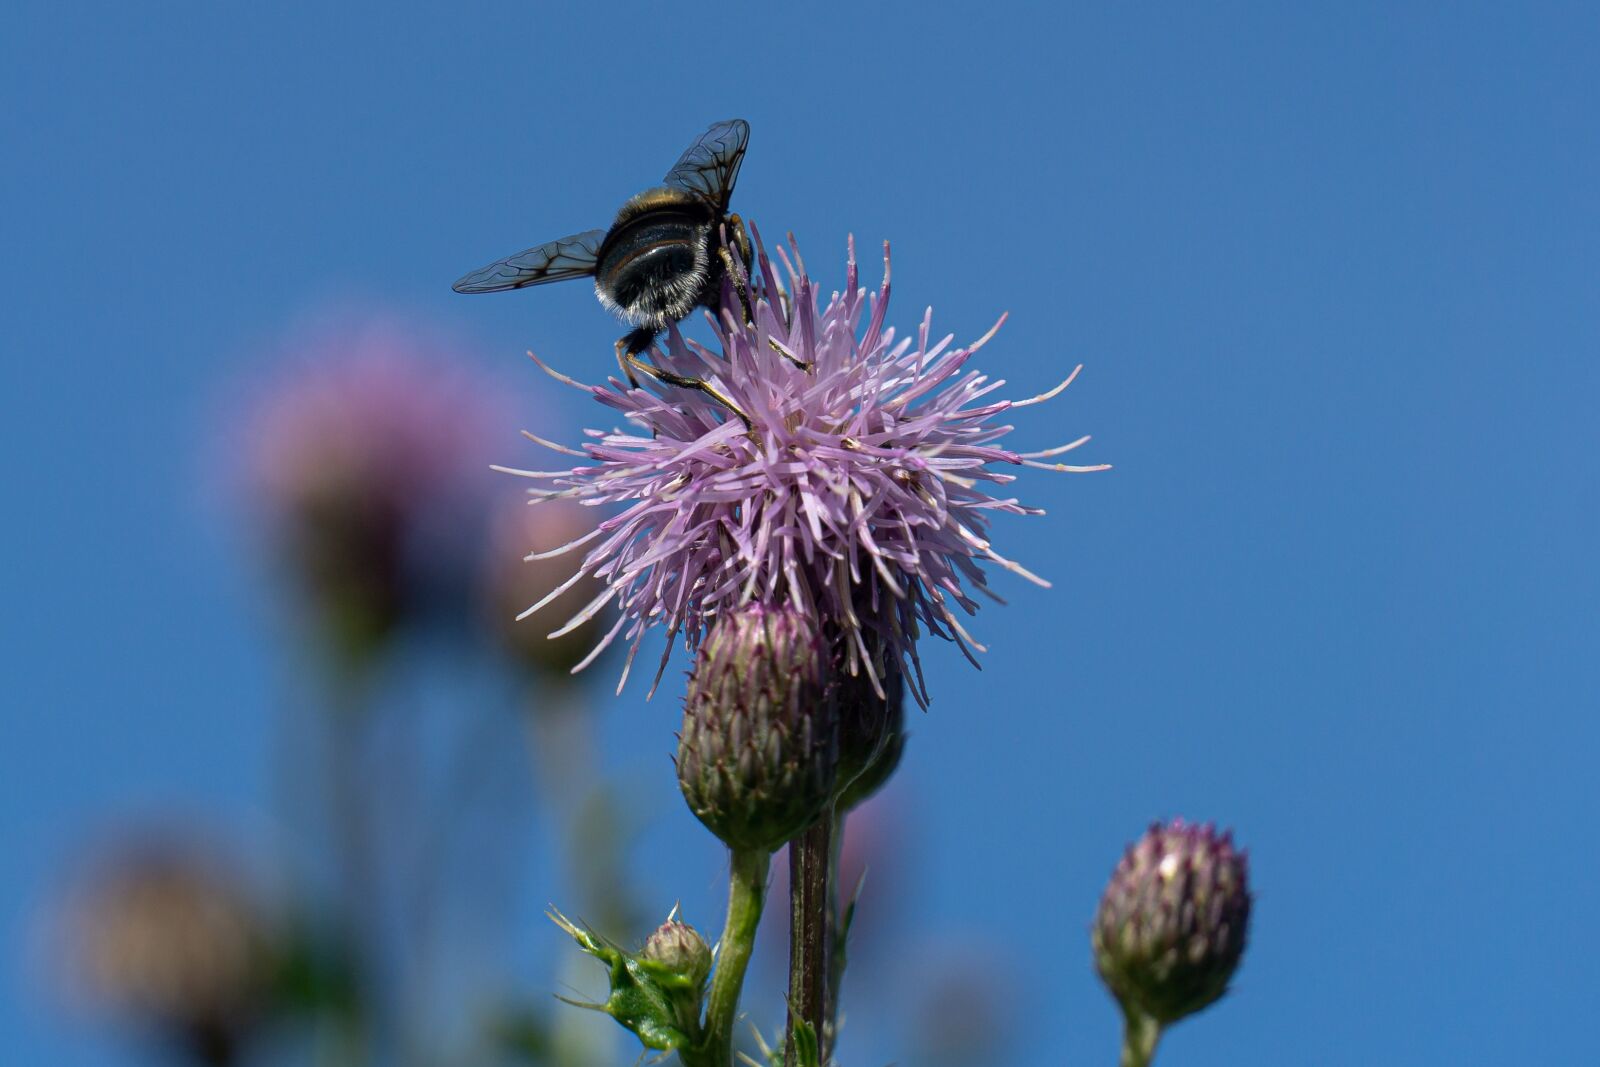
<box><xmin>677</xmin><ymin>605</ymin><xmax>838</xmax><ymax>851</ymax></box>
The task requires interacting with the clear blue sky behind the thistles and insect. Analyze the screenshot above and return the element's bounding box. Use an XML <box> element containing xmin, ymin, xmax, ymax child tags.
<box><xmin>0</xmin><ymin>0</ymin><xmax>1600</xmax><ymax>1067</ymax></box>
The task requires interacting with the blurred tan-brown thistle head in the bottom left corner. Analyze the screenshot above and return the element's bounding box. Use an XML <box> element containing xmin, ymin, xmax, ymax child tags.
<box><xmin>66</xmin><ymin>840</ymin><xmax>275</xmax><ymax>1064</ymax></box>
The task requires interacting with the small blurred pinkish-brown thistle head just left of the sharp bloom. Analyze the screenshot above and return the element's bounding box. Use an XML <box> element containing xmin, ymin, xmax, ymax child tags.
<box><xmin>483</xmin><ymin>494</ymin><xmax>610</xmax><ymax>678</ymax></box>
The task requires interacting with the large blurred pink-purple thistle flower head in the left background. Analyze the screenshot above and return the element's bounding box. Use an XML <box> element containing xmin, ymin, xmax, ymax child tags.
<box><xmin>250</xmin><ymin>322</ymin><xmax>494</xmax><ymax>656</ymax></box>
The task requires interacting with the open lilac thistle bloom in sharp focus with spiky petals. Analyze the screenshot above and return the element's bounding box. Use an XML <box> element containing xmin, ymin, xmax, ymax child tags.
<box><xmin>507</xmin><ymin>233</ymin><xmax>1104</xmax><ymax>704</ymax></box>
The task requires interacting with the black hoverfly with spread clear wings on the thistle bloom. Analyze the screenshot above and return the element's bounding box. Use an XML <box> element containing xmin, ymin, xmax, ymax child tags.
<box><xmin>451</xmin><ymin>118</ymin><xmax>764</xmax><ymax>412</ymax></box>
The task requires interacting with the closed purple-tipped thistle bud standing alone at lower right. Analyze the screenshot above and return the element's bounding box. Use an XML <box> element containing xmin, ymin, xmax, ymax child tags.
<box><xmin>1093</xmin><ymin>819</ymin><xmax>1250</xmax><ymax>1025</ymax></box>
